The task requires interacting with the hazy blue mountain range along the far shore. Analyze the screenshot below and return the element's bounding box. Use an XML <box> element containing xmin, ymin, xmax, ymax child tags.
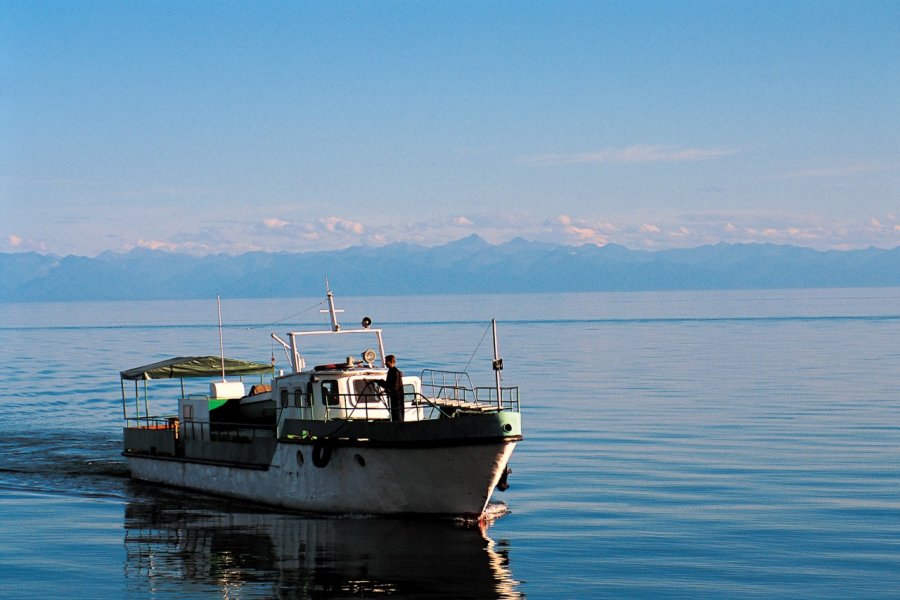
<box><xmin>0</xmin><ymin>235</ymin><xmax>900</xmax><ymax>302</ymax></box>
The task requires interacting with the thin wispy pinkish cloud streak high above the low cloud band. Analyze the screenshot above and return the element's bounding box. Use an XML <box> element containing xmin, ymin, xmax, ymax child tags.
<box><xmin>520</xmin><ymin>144</ymin><xmax>739</xmax><ymax>166</ymax></box>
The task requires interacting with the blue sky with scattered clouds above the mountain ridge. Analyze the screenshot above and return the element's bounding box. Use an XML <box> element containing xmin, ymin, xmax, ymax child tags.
<box><xmin>0</xmin><ymin>0</ymin><xmax>900</xmax><ymax>256</ymax></box>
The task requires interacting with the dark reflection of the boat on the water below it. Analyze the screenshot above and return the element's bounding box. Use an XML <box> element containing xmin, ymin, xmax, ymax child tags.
<box><xmin>125</xmin><ymin>484</ymin><xmax>522</xmax><ymax>598</ymax></box>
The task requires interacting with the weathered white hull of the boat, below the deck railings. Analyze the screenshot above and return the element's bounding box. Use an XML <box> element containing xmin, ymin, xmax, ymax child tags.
<box><xmin>128</xmin><ymin>440</ymin><xmax>516</xmax><ymax>515</ymax></box>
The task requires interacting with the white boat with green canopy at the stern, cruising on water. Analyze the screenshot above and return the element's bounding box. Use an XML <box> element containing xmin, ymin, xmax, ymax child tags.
<box><xmin>120</xmin><ymin>289</ymin><xmax>523</xmax><ymax>519</ymax></box>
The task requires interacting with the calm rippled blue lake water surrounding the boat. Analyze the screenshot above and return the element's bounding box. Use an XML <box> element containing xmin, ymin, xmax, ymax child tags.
<box><xmin>0</xmin><ymin>288</ymin><xmax>900</xmax><ymax>598</ymax></box>
